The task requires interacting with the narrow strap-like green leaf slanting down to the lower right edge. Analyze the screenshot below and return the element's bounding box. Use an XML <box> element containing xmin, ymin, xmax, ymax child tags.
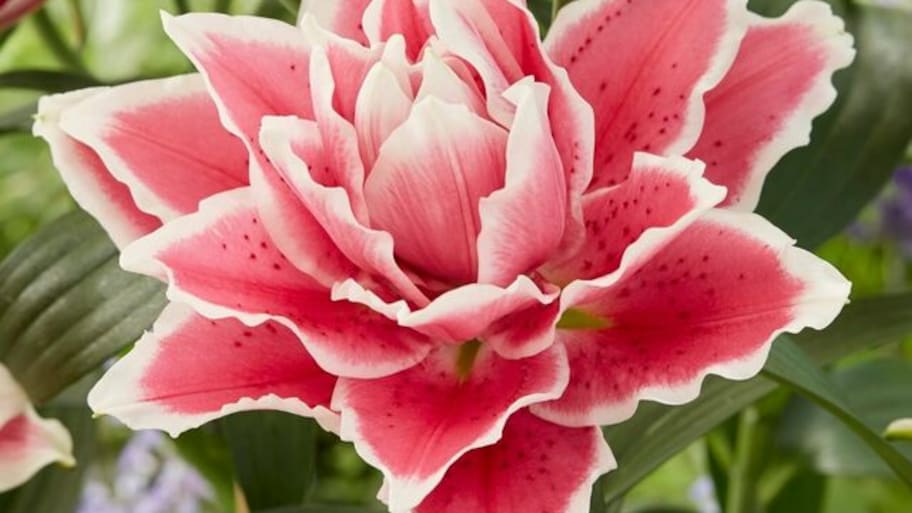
<box><xmin>764</xmin><ymin>340</ymin><xmax>912</xmax><ymax>486</ymax></box>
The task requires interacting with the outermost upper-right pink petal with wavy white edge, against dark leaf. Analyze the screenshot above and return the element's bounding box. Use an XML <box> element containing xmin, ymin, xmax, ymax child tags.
<box><xmin>689</xmin><ymin>0</ymin><xmax>855</xmax><ymax>211</ymax></box>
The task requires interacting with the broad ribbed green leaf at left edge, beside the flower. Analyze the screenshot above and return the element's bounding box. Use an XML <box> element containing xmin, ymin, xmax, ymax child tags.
<box><xmin>0</xmin><ymin>211</ymin><xmax>165</xmax><ymax>403</ymax></box>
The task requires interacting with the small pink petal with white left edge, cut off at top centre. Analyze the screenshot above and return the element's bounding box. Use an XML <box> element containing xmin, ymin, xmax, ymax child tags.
<box><xmin>364</xmin><ymin>0</ymin><xmax>434</xmax><ymax>62</ymax></box>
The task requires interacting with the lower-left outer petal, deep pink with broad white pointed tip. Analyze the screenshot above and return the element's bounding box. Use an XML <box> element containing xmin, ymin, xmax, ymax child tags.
<box><xmin>89</xmin><ymin>303</ymin><xmax>338</xmax><ymax>437</ymax></box>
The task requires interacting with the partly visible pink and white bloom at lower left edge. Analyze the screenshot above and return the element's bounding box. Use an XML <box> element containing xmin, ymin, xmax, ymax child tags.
<box><xmin>0</xmin><ymin>365</ymin><xmax>75</xmax><ymax>492</ymax></box>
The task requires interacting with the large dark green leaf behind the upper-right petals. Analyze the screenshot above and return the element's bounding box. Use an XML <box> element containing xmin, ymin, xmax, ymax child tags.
<box><xmin>755</xmin><ymin>0</ymin><xmax>912</xmax><ymax>247</ymax></box>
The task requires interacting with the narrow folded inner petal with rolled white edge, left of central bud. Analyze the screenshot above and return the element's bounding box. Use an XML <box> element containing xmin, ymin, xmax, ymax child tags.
<box><xmin>260</xmin><ymin>114</ymin><xmax>428</xmax><ymax>306</ymax></box>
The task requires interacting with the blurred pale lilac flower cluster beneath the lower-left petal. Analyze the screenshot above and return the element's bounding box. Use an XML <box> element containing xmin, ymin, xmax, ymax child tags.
<box><xmin>78</xmin><ymin>431</ymin><xmax>213</xmax><ymax>513</ymax></box>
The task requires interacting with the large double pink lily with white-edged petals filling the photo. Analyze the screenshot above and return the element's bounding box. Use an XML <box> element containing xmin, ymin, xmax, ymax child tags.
<box><xmin>36</xmin><ymin>0</ymin><xmax>853</xmax><ymax>513</ymax></box>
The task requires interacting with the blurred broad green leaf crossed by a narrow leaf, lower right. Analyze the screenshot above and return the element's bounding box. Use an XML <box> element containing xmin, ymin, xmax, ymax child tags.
<box><xmin>780</xmin><ymin>359</ymin><xmax>912</xmax><ymax>476</ymax></box>
